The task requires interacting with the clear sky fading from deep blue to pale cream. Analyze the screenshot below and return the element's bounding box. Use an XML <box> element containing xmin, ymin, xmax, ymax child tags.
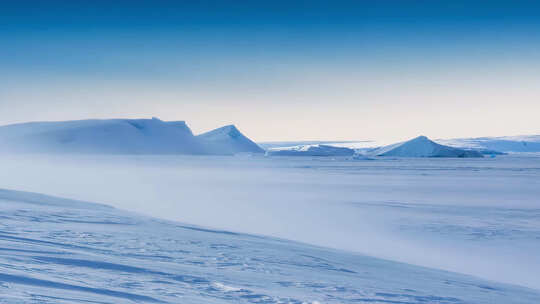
<box><xmin>0</xmin><ymin>0</ymin><xmax>540</xmax><ymax>141</ymax></box>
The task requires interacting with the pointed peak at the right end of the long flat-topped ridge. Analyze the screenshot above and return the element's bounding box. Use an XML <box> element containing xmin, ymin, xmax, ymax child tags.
<box><xmin>197</xmin><ymin>125</ymin><xmax>264</xmax><ymax>155</ymax></box>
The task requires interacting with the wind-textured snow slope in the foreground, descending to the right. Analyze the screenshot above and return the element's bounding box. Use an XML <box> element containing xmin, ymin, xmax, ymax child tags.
<box><xmin>0</xmin><ymin>190</ymin><xmax>540</xmax><ymax>304</ymax></box>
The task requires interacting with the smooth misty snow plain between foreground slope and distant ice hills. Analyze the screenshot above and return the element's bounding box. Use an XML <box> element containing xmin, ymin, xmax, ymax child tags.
<box><xmin>0</xmin><ymin>155</ymin><xmax>540</xmax><ymax>292</ymax></box>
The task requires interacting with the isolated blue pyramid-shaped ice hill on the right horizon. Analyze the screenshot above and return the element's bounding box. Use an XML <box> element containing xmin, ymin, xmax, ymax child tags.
<box><xmin>370</xmin><ymin>136</ymin><xmax>482</xmax><ymax>157</ymax></box>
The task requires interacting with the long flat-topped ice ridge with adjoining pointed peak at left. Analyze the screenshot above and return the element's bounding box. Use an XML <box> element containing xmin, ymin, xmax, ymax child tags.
<box><xmin>0</xmin><ymin>118</ymin><xmax>263</xmax><ymax>155</ymax></box>
